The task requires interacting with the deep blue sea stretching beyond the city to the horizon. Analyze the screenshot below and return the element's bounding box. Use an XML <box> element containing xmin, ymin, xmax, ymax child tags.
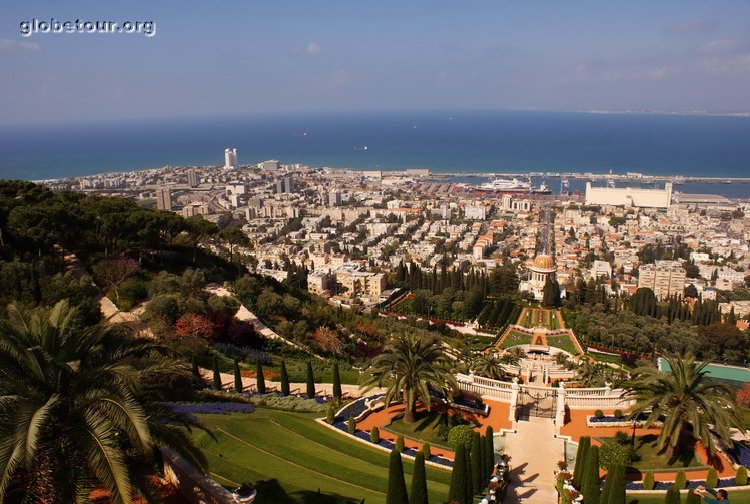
<box><xmin>0</xmin><ymin>111</ymin><xmax>750</xmax><ymax>198</ymax></box>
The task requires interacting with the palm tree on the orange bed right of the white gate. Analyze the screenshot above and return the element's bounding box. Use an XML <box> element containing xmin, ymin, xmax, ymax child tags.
<box><xmin>625</xmin><ymin>355</ymin><xmax>743</xmax><ymax>456</ymax></box>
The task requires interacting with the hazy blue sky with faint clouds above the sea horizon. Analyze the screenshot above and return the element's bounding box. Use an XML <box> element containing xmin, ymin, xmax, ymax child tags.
<box><xmin>0</xmin><ymin>0</ymin><xmax>750</xmax><ymax>125</ymax></box>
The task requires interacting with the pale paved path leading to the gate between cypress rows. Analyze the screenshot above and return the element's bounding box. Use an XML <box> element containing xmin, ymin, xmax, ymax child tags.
<box><xmin>505</xmin><ymin>417</ymin><xmax>563</xmax><ymax>504</ymax></box>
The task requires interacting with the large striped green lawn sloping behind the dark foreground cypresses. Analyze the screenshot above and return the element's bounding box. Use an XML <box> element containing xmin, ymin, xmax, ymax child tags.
<box><xmin>195</xmin><ymin>408</ymin><xmax>450</xmax><ymax>504</ymax></box>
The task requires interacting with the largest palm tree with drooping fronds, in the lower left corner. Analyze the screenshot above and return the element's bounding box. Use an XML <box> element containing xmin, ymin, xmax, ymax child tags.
<box><xmin>0</xmin><ymin>301</ymin><xmax>206</xmax><ymax>504</ymax></box>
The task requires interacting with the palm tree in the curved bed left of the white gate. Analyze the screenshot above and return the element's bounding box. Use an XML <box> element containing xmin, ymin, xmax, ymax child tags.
<box><xmin>362</xmin><ymin>334</ymin><xmax>457</xmax><ymax>424</ymax></box>
